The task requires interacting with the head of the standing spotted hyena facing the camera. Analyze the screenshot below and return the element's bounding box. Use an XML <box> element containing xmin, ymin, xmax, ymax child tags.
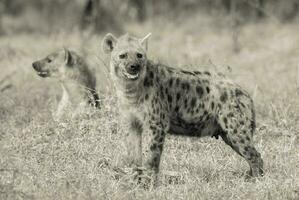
<box><xmin>102</xmin><ymin>33</ymin><xmax>151</xmax><ymax>83</ymax></box>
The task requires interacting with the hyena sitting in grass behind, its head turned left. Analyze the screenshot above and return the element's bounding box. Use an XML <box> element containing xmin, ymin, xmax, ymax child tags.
<box><xmin>32</xmin><ymin>49</ymin><xmax>100</xmax><ymax>121</ymax></box>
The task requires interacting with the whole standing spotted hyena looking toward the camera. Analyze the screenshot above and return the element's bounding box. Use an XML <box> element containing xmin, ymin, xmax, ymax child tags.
<box><xmin>102</xmin><ymin>34</ymin><xmax>263</xmax><ymax>180</ymax></box>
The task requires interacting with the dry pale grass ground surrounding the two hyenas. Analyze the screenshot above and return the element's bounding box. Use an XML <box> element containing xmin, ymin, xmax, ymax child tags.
<box><xmin>0</xmin><ymin>15</ymin><xmax>299</xmax><ymax>200</ymax></box>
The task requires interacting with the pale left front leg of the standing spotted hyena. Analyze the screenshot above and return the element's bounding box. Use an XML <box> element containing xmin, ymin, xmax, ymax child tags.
<box><xmin>126</xmin><ymin>117</ymin><xmax>143</xmax><ymax>167</ymax></box>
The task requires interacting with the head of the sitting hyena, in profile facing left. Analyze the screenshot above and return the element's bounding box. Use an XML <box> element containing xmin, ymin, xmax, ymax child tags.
<box><xmin>32</xmin><ymin>49</ymin><xmax>74</xmax><ymax>79</ymax></box>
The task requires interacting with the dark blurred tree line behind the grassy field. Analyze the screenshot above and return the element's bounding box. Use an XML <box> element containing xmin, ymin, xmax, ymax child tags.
<box><xmin>0</xmin><ymin>0</ymin><xmax>299</xmax><ymax>34</ymax></box>
